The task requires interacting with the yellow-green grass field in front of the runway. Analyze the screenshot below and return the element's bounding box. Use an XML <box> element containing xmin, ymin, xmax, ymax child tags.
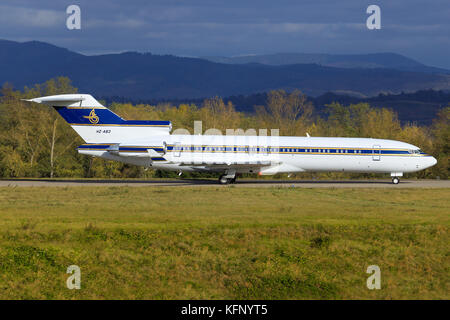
<box><xmin>0</xmin><ymin>186</ymin><xmax>450</xmax><ymax>299</ymax></box>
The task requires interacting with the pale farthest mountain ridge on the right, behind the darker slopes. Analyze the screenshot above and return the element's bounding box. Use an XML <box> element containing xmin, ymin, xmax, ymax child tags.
<box><xmin>203</xmin><ymin>52</ymin><xmax>450</xmax><ymax>74</ymax></box>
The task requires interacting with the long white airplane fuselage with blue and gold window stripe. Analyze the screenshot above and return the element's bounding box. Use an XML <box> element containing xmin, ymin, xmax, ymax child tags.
<box><xmin>79</xmin><ymin>135</ymin><xmax>436</xmax><ymax>176</ymax></box>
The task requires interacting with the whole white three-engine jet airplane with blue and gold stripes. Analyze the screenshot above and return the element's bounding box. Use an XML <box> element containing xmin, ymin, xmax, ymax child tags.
<box><xmin>26</xmin><ymin>94</ymin><xmax>437</xmax><ymax>184</ymax></box>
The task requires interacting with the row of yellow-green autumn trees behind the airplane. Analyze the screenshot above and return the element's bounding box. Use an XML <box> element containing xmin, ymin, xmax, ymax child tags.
<box><xmin>0</xmin><ymin>77</ymin><xmax>450</xmax><ymax>179</ymax></box>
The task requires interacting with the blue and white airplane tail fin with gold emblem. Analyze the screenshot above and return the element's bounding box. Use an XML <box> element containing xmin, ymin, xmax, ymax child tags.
<box><xmin>26</xmin><ymin>94</ymin><xmax>172</xmax><ymax>143</ymax></box>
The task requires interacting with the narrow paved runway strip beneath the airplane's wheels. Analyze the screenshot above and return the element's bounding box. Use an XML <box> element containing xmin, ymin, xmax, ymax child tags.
<box><xmin>0</xmin><ymin>179</ymin><xmax>450</xmax><ymax>188</ymax></box>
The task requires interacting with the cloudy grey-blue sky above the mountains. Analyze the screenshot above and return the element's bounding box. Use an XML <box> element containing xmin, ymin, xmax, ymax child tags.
<box><xmin>0</xmin><ymin>0</ymin><xmax>450</xmax><ymax>68</ymax></box>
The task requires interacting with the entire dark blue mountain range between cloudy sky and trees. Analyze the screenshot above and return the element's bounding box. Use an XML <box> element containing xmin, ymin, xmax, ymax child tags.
<box><xmin>0</xmin><ymin>40</ymin><xmax>450</xmax><ymax>99</ymax></box>
